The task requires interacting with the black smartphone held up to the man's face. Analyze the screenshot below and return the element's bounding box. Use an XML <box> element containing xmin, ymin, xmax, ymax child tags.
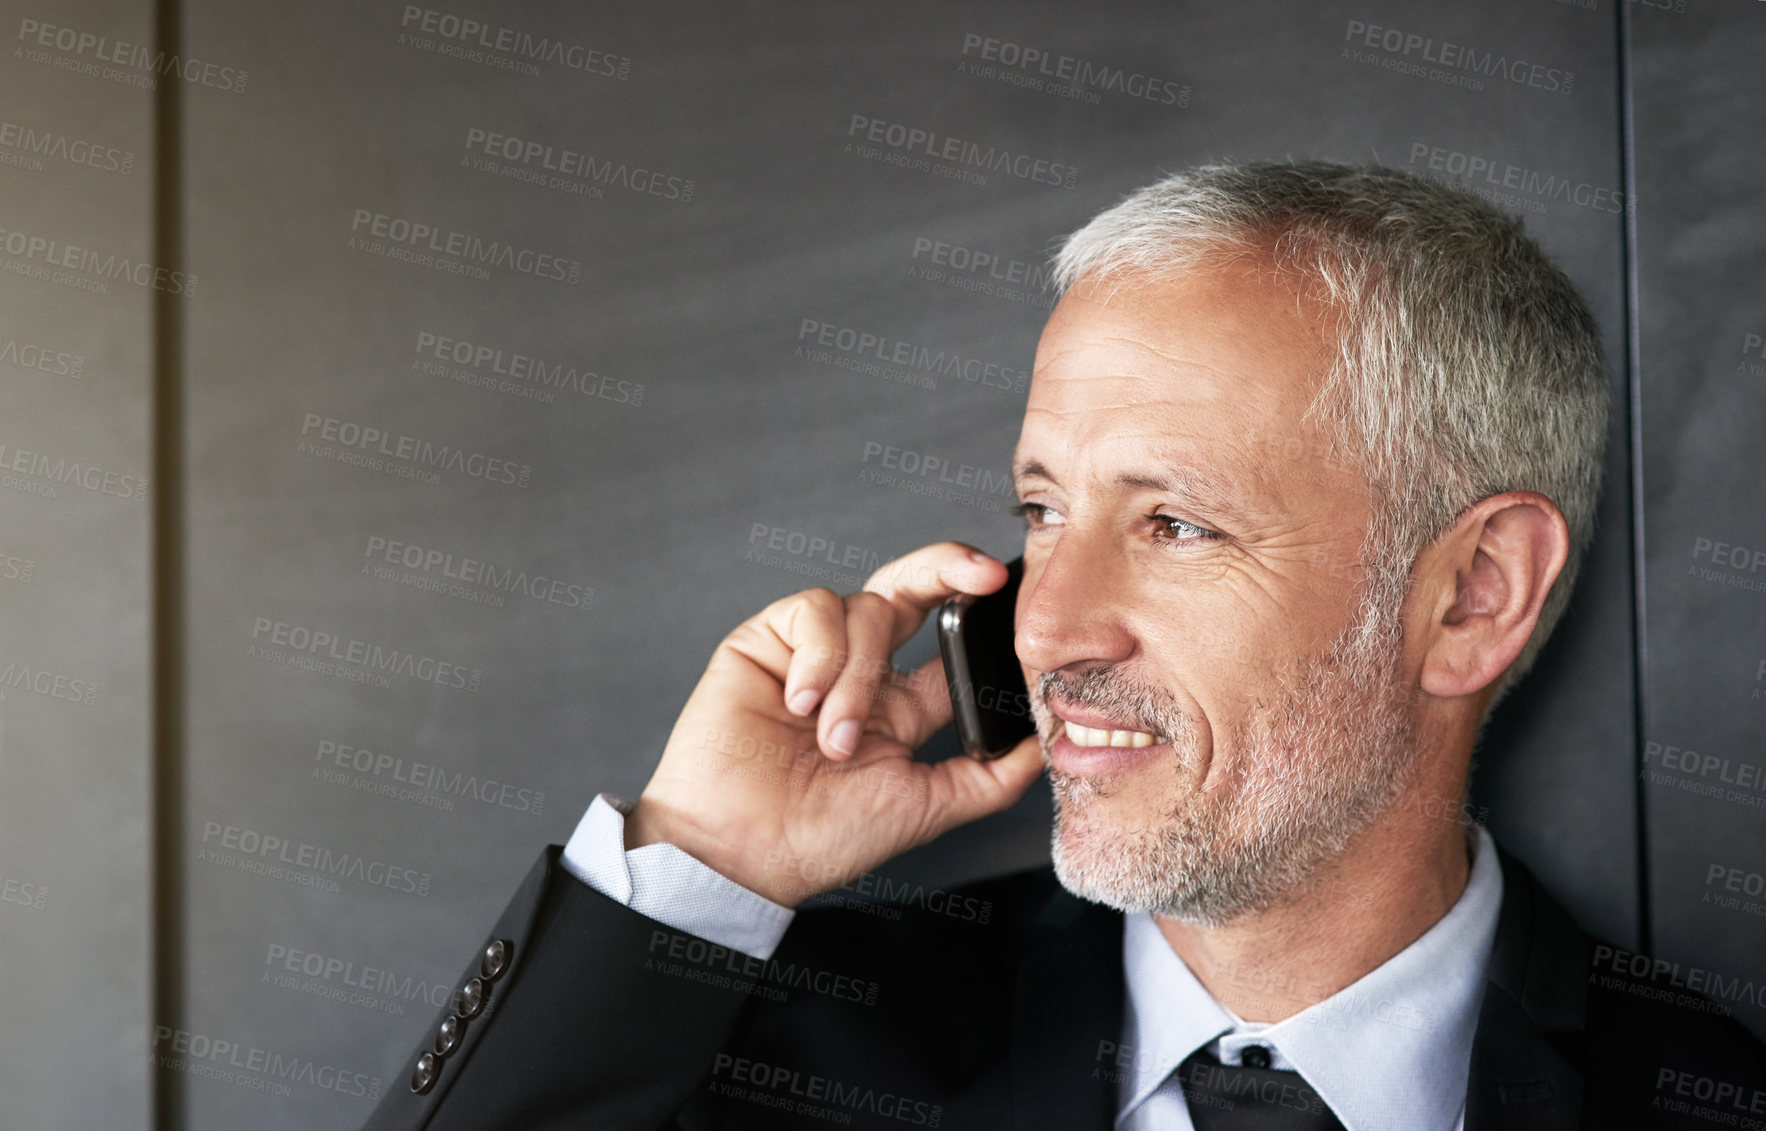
<box><xmin>938</xmin><ymin>557</ymin><xmax>1037</xmax><ymax>758</ymax></box>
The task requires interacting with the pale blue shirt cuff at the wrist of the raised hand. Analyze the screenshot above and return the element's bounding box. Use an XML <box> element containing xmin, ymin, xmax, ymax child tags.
<box><xmin>563</xmin><ymin>793</ymin><xmax>796</xmax><ymax>961</ymax></box>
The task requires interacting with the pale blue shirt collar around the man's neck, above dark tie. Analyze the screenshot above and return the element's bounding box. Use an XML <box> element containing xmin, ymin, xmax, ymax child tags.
<box><xmin>1116</xmin><ymin>827</ymin><xmax>1503</xmax><ymax>1131</ymax></box>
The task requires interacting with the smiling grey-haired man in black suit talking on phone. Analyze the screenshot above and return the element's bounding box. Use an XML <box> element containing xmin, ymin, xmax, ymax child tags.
<box><xmin>369</xmin><ymin>164</ymin><xmax>1766</xmax><ymax>1131</ymax></box>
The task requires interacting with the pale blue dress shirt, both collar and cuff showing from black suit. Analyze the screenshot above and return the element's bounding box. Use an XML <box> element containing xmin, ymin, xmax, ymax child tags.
<box><xmin>563</xmin><ymin>793</ymin><xmax>1503</xmax><ymax>1131</ymax></box>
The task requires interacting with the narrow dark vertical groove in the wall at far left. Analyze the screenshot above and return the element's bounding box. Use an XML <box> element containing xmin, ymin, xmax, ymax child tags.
<box><xmin>148</xmin><ymin>0</ymin><xmax>184</xmax><ymax>1131</ymax></box>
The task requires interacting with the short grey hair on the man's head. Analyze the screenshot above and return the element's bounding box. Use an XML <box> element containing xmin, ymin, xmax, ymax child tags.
<box><xmin>1053</xmin><ymin>163</ymin><xmax>1607</xmax><ymax>696</ymax></box>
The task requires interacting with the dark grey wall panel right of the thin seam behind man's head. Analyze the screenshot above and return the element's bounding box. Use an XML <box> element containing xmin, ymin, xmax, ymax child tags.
<box><xmin>1632</xmin><ymin>4</ymin><xmax>1766</xmax><ymax>1060</ymax></box>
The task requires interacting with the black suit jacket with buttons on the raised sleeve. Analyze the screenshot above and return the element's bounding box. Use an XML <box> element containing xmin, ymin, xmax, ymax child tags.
<box><xmin>364</xmin><ymin>846</ymin><xmax>1766</xmax><ymax>1131</ymax></box>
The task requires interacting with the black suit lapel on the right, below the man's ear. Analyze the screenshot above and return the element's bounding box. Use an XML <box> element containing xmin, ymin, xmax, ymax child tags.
<box><xmin>1466</xmin><ymin>848</ymin><xmax>1588</xmax><ymax>1131</ymax></box>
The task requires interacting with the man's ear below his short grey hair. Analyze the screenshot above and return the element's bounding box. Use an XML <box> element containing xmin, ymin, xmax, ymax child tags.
<box><xmin>1411</xmin><ymin>491</ymin><xmax>1570</xmax><ymax>698</ymax></box>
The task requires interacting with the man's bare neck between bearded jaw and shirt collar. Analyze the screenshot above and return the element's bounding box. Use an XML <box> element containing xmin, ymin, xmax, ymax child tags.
<box><xmin>1153</xmin><ymin>804</ymin><xmax>1469</xmax><ymax>1021</ymax></box>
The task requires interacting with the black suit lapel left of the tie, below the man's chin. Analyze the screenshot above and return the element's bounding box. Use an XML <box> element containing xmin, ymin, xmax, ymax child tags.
<box><xmin>1012</xmin><ymin>891</ymin><xmax>1123</xmax><ymax>1131</ymax></box>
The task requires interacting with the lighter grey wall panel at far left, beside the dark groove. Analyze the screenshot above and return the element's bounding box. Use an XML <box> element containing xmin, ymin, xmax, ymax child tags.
<box><xmin>0</xmin><ymin>0</ymin><xmax>157</xmax><ymax>1127</ymax></box>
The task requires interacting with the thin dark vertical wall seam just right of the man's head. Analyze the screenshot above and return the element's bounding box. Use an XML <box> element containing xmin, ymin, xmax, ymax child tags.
<box><xmin>1612</xmin><ymin>2</ymin><xmax>1655</xmax><ymax>954</ymax></box>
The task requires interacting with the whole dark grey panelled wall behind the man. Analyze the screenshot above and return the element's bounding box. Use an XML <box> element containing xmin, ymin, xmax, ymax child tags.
<box><xmin>0</xmin><ymin>0</ymin><xmax>1766</xmax><ymax>1129</ymax></box>
